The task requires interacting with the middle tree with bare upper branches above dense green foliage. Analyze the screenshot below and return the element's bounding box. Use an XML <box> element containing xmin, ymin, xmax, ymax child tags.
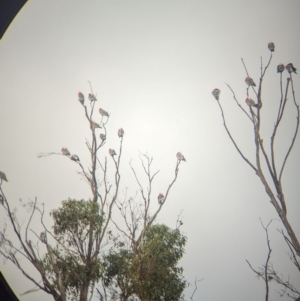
<box><xmin>99</xmin><ymin>153</ymin><xmax>186</xmax><ymax>301</ymax></box>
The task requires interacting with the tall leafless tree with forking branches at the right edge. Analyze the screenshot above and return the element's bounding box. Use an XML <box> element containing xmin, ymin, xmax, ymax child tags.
<box><xmin>212</xmin><ymin>42</ymin><xmax>300</xmax><ymax>252</ymax></box>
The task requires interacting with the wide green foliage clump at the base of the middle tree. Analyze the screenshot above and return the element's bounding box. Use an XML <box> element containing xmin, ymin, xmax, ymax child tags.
<box><xmin>104</xmin><ymin>225</ymin><xmax>186</xmax><ymax>301</ymax></box>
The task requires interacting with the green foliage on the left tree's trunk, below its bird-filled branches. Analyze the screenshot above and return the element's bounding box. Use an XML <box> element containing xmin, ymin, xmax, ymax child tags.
<box><xmin>43</xmin><ymin>199</ymin><xmax>104</xmax><ymax>297</ymax></box>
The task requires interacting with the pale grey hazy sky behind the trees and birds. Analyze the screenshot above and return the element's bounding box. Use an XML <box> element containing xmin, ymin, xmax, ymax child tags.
<box><xmin>0</xmin><ymin>0</ymin><xmax>300</xmax><ymax>301</ymax></box>
